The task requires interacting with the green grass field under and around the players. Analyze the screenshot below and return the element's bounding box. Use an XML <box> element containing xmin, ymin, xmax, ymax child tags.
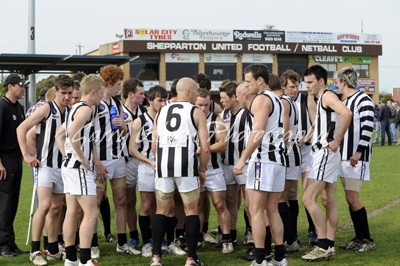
<box><xmin>0</xmin><ymin>145</ymin><xmax>400</xmax><ymax>266</ymax></box>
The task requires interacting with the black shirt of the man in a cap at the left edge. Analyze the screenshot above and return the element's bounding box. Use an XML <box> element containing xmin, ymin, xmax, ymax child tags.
<box><xmin>0</xmin><ymin>96</ymin><xmax>25</xmax><ymax>158</ymax></box>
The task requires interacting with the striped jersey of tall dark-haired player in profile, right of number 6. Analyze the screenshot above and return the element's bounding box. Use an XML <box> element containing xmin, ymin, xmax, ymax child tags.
<box><xmin>250</xmin><ymin>90</ymin><xmax>286</xmax><ymax>166</ymax></box>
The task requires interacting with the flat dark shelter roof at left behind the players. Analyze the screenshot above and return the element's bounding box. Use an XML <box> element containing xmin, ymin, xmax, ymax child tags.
<box><xmin>0</xmin><ymin>54</ymin><xmax>131</xmax><ymax>76</ymax></box>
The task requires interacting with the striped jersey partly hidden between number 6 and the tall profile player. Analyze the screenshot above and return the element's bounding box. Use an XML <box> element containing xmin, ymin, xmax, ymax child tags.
<box><xmin>222</xmin><ymin>108</ymin><xmax>249</xmax><ymax>165</ymax></box>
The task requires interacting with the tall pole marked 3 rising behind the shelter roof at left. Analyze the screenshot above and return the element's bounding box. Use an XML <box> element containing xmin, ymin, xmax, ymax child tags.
<box><xmin>26</xmin><ymin>0</ymin><xmax>36</xmax><ymax>108</ymax></box>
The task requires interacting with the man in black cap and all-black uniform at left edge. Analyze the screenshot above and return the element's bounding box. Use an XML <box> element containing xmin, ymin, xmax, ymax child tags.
<box><xmin>0</xmin><ymin>74</ymin><xmax>29</xmax><ymax>257</ymax></box>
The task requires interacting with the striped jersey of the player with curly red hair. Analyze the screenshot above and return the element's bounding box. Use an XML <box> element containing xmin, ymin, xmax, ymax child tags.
<box><xmin>93</xmin><ymin>97</ymin><xmax>125</xmax><ymax>161</ymax></box>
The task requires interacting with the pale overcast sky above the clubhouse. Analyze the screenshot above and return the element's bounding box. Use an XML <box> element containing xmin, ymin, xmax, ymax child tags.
<box><xmin>0</xmin><ymin>0</ymin><xmax>400</xmax><ymax>93</ymax></box>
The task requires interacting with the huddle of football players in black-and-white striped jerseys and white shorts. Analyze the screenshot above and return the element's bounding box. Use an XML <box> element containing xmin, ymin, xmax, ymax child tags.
<box><xmin>12</xmin><ymin>64</ymin><xmax>375</xmax><ymax>266</ymax></box>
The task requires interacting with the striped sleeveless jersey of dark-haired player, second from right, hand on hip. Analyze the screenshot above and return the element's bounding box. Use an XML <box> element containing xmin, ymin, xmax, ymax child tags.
<box><xmin>312</xmin><ymin>90</ymin><xmax>340</xmax><ymax>151</ymax></box>
